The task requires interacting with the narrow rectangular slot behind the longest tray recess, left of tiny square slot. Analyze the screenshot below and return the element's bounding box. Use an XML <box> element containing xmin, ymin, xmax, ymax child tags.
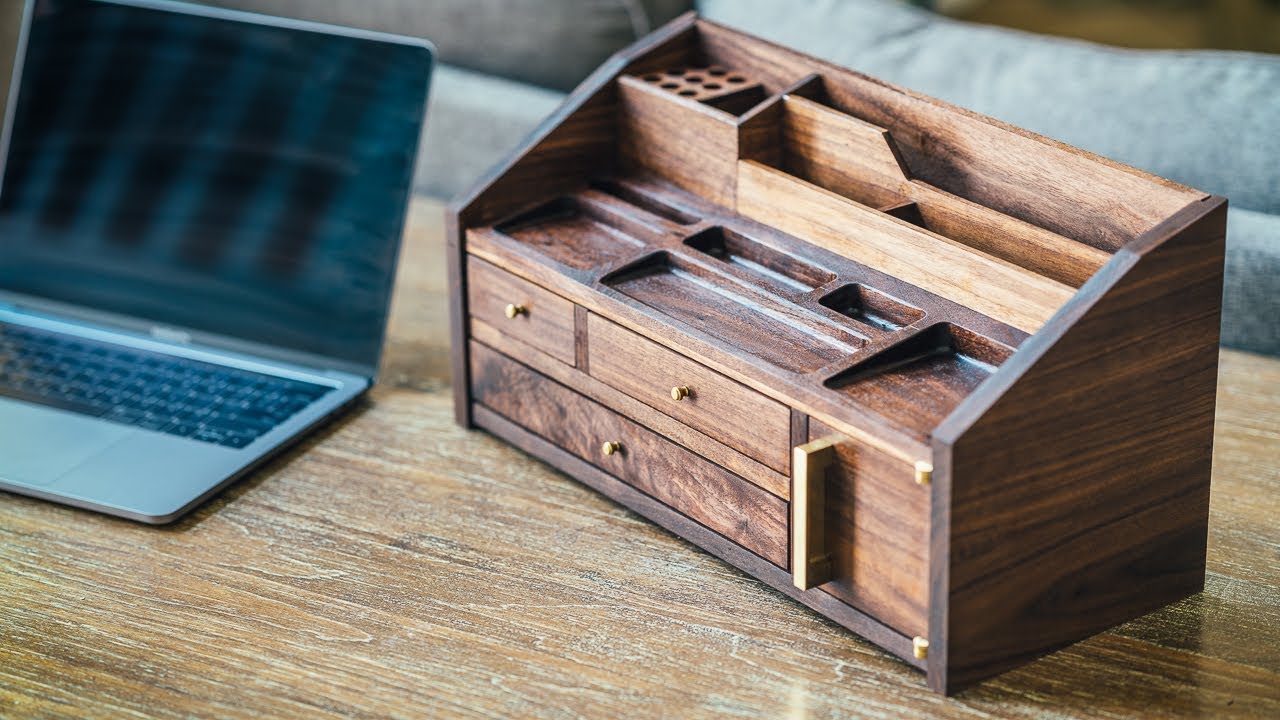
<box><xmin>685</xmin><ymin>225</ymin><xmax>836</xmax><ymax>296</ymax></box>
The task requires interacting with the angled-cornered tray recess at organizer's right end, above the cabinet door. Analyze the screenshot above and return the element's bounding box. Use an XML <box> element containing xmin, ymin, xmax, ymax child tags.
<box><xmin>826</xmin><ymin>323</ymin><xmax>1014</xmax><ymax>437</ymax></box>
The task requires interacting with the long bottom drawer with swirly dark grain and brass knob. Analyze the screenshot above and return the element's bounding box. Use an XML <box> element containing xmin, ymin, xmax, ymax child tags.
<box><xmin>471</xmin><ymin>342</ymin><xmax>788</xmax><ymax>569</ymax></box>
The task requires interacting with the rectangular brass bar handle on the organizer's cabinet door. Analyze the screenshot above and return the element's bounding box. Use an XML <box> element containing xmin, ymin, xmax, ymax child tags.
<box><xmin>791</xmin><ymin>437</ymin><xmax>837</xmax><ymax>591</ymax></box>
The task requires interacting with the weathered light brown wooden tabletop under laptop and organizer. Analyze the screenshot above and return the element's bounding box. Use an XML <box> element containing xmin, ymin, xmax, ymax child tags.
<box><xmin>0</xmin><ymin>201</ymin><xmax>1280</xmax><ymax>719</ymax></box>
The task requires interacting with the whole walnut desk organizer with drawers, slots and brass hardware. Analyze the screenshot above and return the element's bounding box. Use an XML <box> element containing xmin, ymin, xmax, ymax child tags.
<box><xmin>449</xmin><ymin>15</ymin><xmax>1226</xmax><ymax>693</ymax></box>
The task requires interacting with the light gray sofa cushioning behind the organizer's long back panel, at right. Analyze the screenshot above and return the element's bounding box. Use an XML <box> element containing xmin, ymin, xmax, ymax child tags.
<box><xmin>699</xmin><ymin>0</ymin><xmax>1280</xmax><ymax>354</ymax></box>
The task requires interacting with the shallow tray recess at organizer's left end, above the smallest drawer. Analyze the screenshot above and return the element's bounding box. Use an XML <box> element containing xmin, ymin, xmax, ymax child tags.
<box><xmin>494</xmin><ymin>197</ymin><xmax>650</xmax><ymax>270</ymax></box>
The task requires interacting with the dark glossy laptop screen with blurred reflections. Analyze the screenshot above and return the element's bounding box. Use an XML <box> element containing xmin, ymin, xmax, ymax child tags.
<box><xmin>0</xmin><ymin>0</ymin><xmax>431</xmax><ymax>368</ymax></box>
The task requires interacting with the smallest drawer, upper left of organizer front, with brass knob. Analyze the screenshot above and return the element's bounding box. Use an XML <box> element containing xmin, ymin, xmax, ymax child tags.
<box><xmin>467</xmin><ymin>256</ymin><xmax>575</xmax><ymax>365</ymax></box>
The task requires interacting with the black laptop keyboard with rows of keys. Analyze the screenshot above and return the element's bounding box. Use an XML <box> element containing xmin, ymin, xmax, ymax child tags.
<box><xmin>0</xmin><ymin>323</ymin><xmax>333</xmax><ymax>448</ymax></box>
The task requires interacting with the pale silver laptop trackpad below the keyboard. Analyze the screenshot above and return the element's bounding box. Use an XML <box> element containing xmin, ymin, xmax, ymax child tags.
<box><xmin>0</xmin><ymin>397</ymin><xmax>136</xmax><ymax>486</ymax></box>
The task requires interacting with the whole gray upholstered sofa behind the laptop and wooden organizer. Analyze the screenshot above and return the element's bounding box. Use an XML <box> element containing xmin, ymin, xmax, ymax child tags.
<box><xmin>99</xmin><ymin>0</ymin><xmax>1280</xmax><ymax>355</ymax></box>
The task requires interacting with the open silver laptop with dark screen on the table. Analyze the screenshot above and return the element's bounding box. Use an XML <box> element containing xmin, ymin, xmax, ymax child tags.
<box><xmin>0</xmin><ymin>0</ymin><xmax>433</xmax><ymax>524</ymax></box>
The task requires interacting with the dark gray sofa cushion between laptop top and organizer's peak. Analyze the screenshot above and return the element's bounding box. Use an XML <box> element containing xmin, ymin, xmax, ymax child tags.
<box><xmin>192</xmin><ymin>0</ymin><xmax>692</xmax><ymax>90</ymax></box>
